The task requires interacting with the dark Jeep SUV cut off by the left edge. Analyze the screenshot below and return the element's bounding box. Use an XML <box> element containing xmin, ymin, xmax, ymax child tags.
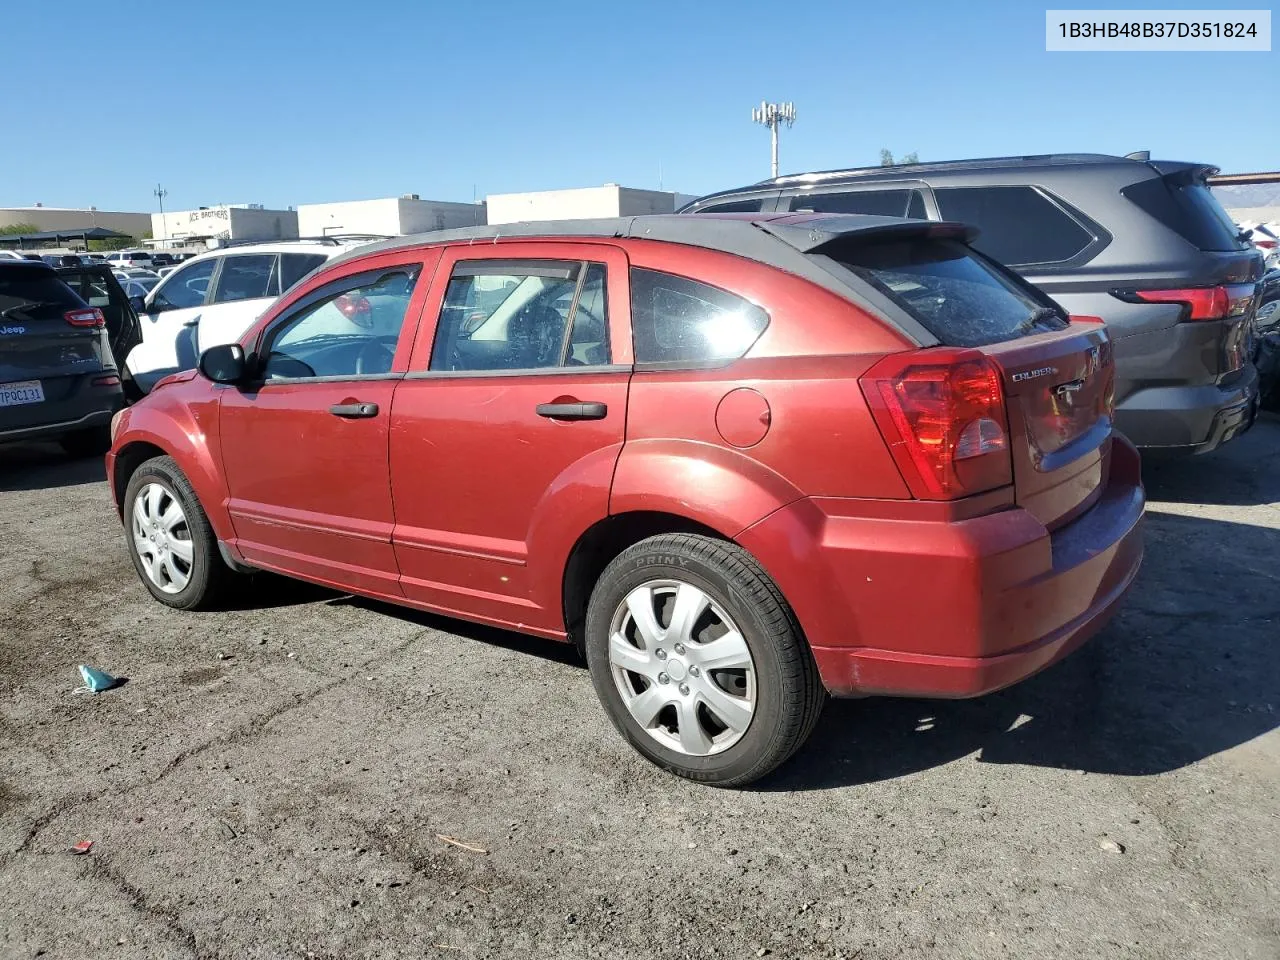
<box><xmin>0</xmin><ymin>260</ymin><xmax>124</xmax><ymax>457</ymax></box>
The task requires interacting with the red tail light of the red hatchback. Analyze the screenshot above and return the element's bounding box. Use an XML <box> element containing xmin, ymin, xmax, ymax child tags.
<box><xmin>859</xmin><ymin>349</ymin><xmax>1014</xmax><ymax>500</ymax></box>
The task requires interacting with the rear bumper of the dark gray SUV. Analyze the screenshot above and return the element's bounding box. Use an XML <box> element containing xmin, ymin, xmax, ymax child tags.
<box><xmin>1116</xmin><ymin>362</ymin><xmax>1258</xmax><ymax>453</ymax></box>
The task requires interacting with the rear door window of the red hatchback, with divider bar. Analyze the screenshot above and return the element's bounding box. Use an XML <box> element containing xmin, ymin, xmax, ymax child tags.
<box><xmin>430</xmin><ymin>260</ymin><xmax>609</xmax><ymax>372</ymax></box>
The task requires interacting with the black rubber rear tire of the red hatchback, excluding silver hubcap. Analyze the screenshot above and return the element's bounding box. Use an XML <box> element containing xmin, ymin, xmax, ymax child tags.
<box><xmin>586</xmin><ymin>534</ymin><xmax>827</xmax><ymax>787</ymax></box>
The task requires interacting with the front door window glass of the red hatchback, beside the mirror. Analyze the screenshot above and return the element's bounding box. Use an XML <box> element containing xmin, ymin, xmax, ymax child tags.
<box><xmin>262</xmin><ymin>268</ymin><xmax>417</xmax><ymax>380</ymax></box>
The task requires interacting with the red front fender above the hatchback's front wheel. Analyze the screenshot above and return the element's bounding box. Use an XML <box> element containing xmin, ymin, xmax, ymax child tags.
<box><xmin>111</xmin><ymin>380</ymin><xmax>234</xmax><ymax>541</ymax></box>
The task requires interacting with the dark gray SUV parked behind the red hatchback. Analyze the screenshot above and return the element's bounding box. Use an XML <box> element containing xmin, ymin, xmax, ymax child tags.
<box><xmin>681</xmin><ymin>154</ymin><xmax>1263</xmax><ymax>453</ymax></box>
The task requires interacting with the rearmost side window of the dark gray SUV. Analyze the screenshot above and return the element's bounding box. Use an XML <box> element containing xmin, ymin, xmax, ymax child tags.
<box><xmin>933</xmin><ymin>187</ymin><xmax>1093</xmax><ymax>265</ymax></box>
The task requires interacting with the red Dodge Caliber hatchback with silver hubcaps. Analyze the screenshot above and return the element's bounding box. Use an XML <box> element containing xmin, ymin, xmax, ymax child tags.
<box><xmin>108</xmin><ymin>214</ymin><xmax>1144</xmax><ymax>786</ymax></box>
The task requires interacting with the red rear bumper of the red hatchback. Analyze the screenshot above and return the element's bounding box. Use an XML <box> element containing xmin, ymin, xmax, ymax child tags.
<box><xmin>739</xmin><ymin>438</ymin><xmax>1144</xmax><ymax>698</ymax></box>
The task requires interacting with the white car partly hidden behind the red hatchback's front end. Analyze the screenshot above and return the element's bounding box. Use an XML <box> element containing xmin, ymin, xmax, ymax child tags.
<box><xmin>125</xmin><ymin>238</ymin><xmax>369</xmax><ymax>393</ymax></box>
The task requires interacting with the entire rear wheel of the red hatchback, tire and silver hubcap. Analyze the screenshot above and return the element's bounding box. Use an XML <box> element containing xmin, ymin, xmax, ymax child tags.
<box><xmin>586</xmin><ymin>534</ymin><xmax>826</xmax><ymax>786</ymax></box>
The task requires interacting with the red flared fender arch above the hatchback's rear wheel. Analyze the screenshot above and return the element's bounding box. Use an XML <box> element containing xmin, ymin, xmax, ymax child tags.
<box><xmin>609</xmin><ymin>439</ymin><xmax>803</xmax><ymax>539</ymax></box>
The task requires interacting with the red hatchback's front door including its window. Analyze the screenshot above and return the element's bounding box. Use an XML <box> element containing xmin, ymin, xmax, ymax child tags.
<box><xmin>219</xmin><ymin>255</ymin><xmax>426</xmax><ymax>596</ymax></box>
